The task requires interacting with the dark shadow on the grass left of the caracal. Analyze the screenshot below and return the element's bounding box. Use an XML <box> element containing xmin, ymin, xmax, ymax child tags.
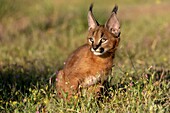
<box><xmin>0</xmin><ymin>62</ymin><xmax>54</xmax><ymax>103</ymax></box>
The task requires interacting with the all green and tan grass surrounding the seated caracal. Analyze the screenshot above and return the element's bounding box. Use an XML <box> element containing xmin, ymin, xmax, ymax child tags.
<box><xmin>0</xmin><ymin>0</ymin><xmax>170</xmax><ymax>113</ymax></box>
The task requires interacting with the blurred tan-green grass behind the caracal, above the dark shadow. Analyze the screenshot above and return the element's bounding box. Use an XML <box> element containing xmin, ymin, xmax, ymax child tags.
<box><xmin>0</xmin><ymin>0</ymin><xmax>170</xmax><ymax>67</ymax></box>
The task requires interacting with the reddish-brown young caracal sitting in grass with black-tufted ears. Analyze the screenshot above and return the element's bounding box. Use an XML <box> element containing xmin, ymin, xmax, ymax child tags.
<box><xmin>56</xmin><ymin>5</ymin><xmax>120</xmax><ymax>99</ymax></box>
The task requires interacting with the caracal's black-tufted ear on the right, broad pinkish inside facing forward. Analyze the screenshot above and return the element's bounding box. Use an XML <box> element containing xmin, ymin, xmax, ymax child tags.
<box><xmin>105</xmin><ymin>5</ymin><xmax>120</xmax><ymax>37</ymax></box>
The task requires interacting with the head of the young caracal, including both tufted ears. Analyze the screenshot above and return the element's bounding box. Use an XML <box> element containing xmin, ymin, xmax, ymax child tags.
<box><xmin>87</xmin><ymin>5</ymin><xmax>120</xmax><ymax>55</ymax></box>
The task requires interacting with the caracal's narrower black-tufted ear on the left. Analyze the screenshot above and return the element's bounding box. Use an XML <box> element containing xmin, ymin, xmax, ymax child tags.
<box><xmin>87</xmin><ymin>4</ymin><xmax>99</xmax><ymax>30</ymax></box>
